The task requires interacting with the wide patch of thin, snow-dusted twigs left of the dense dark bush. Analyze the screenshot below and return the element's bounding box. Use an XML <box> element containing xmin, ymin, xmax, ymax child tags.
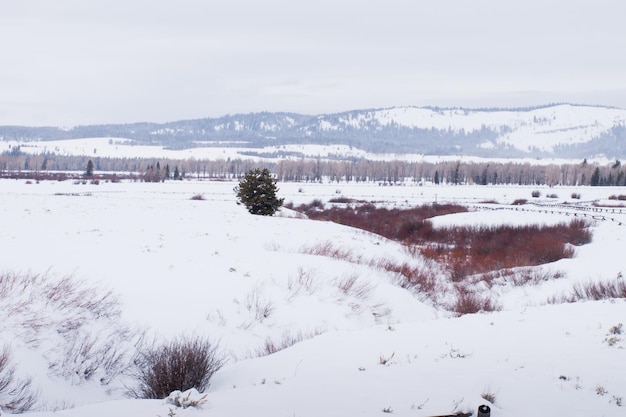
<box><xmin>0</xmin><ymin>273</ymin><xmax>139</xmax><ymax>385</ymax></box>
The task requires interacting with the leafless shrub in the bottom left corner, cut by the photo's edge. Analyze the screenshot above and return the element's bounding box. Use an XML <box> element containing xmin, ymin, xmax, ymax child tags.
<box><xmin>0</xmin><ymin>347</ymin><xmax>38</xmax><ymax>414</ymax></box>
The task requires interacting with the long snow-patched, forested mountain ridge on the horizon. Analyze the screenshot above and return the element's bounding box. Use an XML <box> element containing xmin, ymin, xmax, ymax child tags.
<box><xmin>0</xmin><ymin>104</ymin><xmax>626</xmax><ymax>159</ymax></box>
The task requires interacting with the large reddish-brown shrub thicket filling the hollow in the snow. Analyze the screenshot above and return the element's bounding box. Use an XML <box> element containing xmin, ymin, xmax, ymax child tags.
<box><xmin>295</xmin><ymin>201</ymin><xmax>602</xmax><ymax>315</ymax></box>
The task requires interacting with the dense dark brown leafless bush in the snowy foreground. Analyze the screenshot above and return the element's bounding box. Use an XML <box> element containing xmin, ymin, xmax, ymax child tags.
<box><xmin>129</xmin><ymin>336</ymin><xmax>225</xmax><ymax>399</ymax></box>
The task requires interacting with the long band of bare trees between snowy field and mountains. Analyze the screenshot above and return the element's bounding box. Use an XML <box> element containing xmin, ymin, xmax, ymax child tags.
<box><xmin>0</xmin><ymin>152</ymin><xmax>626</xmax><ymax>186</ymax></box>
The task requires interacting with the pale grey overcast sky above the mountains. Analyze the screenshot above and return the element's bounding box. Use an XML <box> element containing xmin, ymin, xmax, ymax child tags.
<box><xmin>0</xmin><ymin>0</ymin><xmax>626</xmax><ymax>126</ymax></box>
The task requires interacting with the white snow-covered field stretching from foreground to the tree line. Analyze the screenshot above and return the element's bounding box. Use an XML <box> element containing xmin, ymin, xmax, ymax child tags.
<box><xmin>0</xmin><ymin>180</ymin><xmax>626</xmax><ymax>417</ymax></box>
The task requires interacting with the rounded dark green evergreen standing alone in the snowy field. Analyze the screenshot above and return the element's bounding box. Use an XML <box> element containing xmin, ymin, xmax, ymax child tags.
<box><xmin>234</xmin><ymin>168</ymin><xmax>284</xmax><ymax>216</ymax></box>
